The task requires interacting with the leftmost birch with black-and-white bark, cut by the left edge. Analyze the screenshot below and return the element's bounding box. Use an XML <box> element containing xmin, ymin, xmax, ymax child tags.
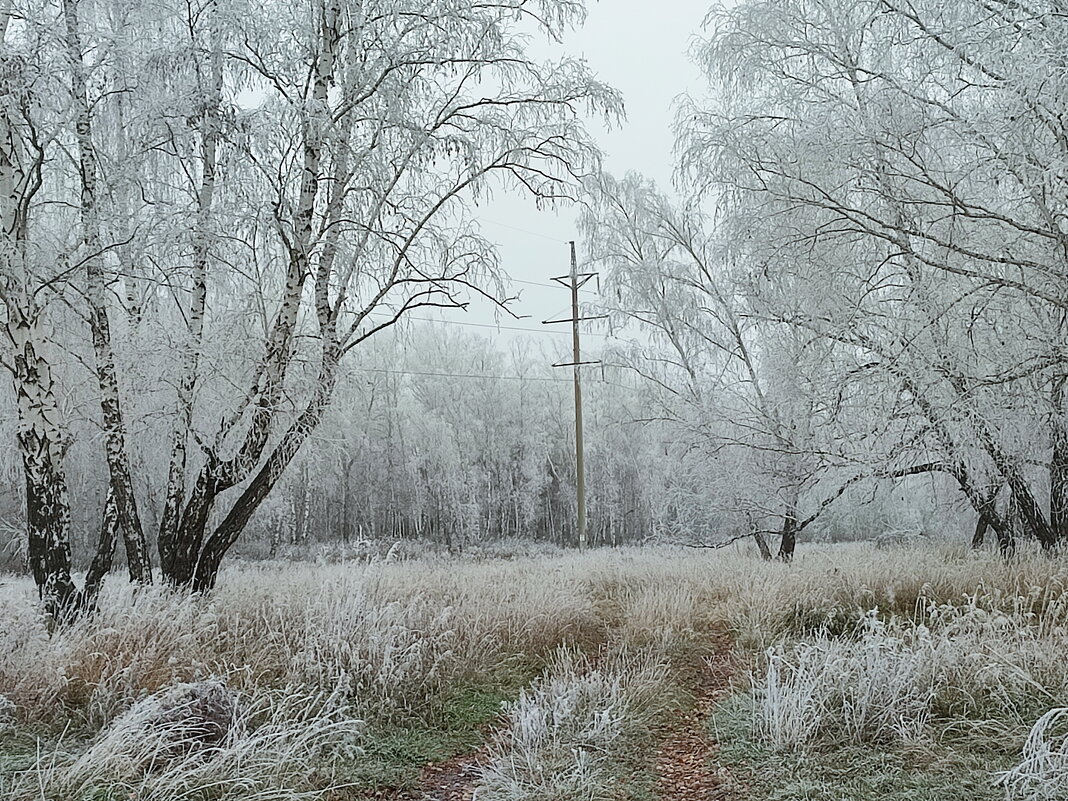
<box><xmin>0</xmin><ymin>4</ymin><xmax>132</xmax><ymax>619</ymax></box>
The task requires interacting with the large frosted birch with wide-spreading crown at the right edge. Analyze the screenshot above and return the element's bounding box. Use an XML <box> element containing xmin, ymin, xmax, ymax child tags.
<box><xmin>679</xmin><ymin>0</ymin><xmax>1066</xmax><ymax>548</ymax></box>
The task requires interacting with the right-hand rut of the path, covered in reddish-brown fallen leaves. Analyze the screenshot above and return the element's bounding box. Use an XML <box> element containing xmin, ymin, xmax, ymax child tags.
<box><xmin>656</xmin><ymin>635</ymin><xmax>743</xmax><ymax>801</ymax></box>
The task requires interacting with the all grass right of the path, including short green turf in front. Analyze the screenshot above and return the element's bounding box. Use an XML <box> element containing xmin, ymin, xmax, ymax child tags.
<box><xmin>709</xmin><ymin>549</ymin><xmax>1068</xmax><ymax>801</ymax></box>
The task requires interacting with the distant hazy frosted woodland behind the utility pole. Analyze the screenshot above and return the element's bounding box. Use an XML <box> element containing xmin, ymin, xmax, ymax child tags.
<box><xmin>227</xmin><ymin>324</ymin><xmax>666</xmax><ymax>553</ymax></box>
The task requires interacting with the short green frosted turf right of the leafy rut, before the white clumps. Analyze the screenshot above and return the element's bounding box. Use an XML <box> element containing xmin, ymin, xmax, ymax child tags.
<box><xmin>710</xmin><ymin>693</ymin><xmax>1012</xmax><ymax>801</ymax></box>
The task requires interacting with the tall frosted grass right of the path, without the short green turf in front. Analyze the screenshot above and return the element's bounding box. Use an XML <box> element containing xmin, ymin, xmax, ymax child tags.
<box><xmin>735</xmin><ymin>550</ymin><xmax>1068</xmax><ymax>801</ymax></box>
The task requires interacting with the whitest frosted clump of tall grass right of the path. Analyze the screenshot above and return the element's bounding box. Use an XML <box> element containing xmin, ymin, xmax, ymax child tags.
<box><xmin>755</xmin><ymin>598</ymin><xmax>1068</xmax><ymax>751</ymax></box>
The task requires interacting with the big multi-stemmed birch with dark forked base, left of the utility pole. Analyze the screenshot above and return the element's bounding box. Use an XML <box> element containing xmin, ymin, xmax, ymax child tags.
<box><xmin>133</xmin><ymin>0</ymin><xmax>619</xmax><ymax>588</ymax></box>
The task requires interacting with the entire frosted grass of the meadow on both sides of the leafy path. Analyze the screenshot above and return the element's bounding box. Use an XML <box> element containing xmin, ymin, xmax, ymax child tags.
<box><xmin>0</xmin><ymin>545</ymin><xmax>1068</xmax><ymax>801</ymax></box>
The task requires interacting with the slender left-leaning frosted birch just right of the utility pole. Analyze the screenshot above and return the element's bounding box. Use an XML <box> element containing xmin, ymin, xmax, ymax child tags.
<box><xmin>584</xmin><ymin>175</ymin><xmax>871</xmax><ymax>560</ymax></box>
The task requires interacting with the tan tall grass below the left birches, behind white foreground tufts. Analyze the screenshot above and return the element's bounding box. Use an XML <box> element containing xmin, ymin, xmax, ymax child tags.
<box><xmin>0</xmin><ymin>565</ymin><xmax>600</xmax><ymax>731</ymax></box>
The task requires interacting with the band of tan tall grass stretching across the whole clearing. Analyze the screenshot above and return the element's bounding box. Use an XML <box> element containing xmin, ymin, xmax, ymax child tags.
<box><xmin>6</xmin><ymin>546</ymin><xmax>1068</xmax><ymax>731</ymax></box>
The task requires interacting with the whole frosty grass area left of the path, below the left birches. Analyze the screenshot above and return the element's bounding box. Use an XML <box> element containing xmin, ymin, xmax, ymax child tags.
<box><xmin>0</xmin><ymin>552</ymin><xmax>711</xmax><ymax>801</ymax></box>
